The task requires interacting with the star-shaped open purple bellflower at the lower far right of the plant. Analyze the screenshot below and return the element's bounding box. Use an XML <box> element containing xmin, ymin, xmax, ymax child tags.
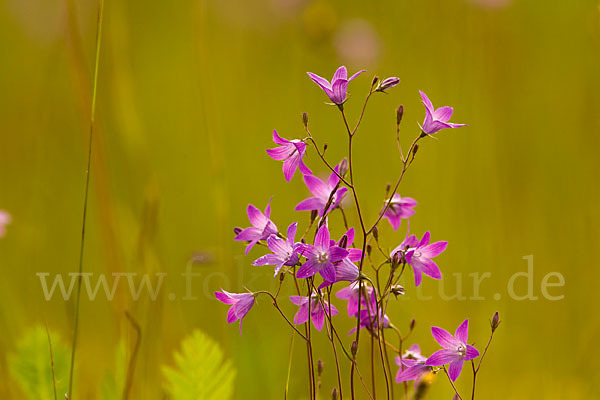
<box><xmin>425</xmin><ymin>319</ymin><xmax>479</xmax><ymax>381</ymax></box>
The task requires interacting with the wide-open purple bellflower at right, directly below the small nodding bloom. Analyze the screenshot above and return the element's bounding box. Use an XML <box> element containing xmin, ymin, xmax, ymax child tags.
<box><xmin>392</xmin><ymin>232</ymin><xmax>448</xmax><ymax>286</ymax></box>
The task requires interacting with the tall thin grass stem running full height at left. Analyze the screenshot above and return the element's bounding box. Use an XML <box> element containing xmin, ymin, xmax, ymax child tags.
<box><xmin>67</xmin><ymin>0</ymin><xmax>104</xmax><ymax>400</ymax></box>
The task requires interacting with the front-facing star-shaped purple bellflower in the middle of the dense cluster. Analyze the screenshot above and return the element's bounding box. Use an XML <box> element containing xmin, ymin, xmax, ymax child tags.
<box><xmin>296</xmin><ymin>225</ymin><xmax>349</xmax><ymax>282</ymax></box>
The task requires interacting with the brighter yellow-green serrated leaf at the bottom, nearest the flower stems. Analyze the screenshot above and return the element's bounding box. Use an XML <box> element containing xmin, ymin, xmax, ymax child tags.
<box><xmin>162</xmin><ymin>330</ymin><xmax>235</xmax><ymax>400</ymax></box>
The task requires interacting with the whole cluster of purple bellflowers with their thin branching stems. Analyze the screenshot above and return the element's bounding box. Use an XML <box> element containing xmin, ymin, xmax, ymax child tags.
<box><xmin>215</xmin><ymin>66</ymin><xmax>494</xmax><ymax>398</ymax></box>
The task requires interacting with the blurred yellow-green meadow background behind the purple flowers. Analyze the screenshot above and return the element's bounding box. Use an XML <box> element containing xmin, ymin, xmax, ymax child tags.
<box><xmin>0</xmin><ymin>0</ymin><xmax>600</xmax><ymax>399</ymax></box>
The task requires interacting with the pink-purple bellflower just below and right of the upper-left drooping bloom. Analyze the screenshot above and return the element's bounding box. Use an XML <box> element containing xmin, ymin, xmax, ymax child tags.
<box><xmin>296</xmin><ymin>165</ymin><xmax>348</xmax><ymax>217</ymax></box>
